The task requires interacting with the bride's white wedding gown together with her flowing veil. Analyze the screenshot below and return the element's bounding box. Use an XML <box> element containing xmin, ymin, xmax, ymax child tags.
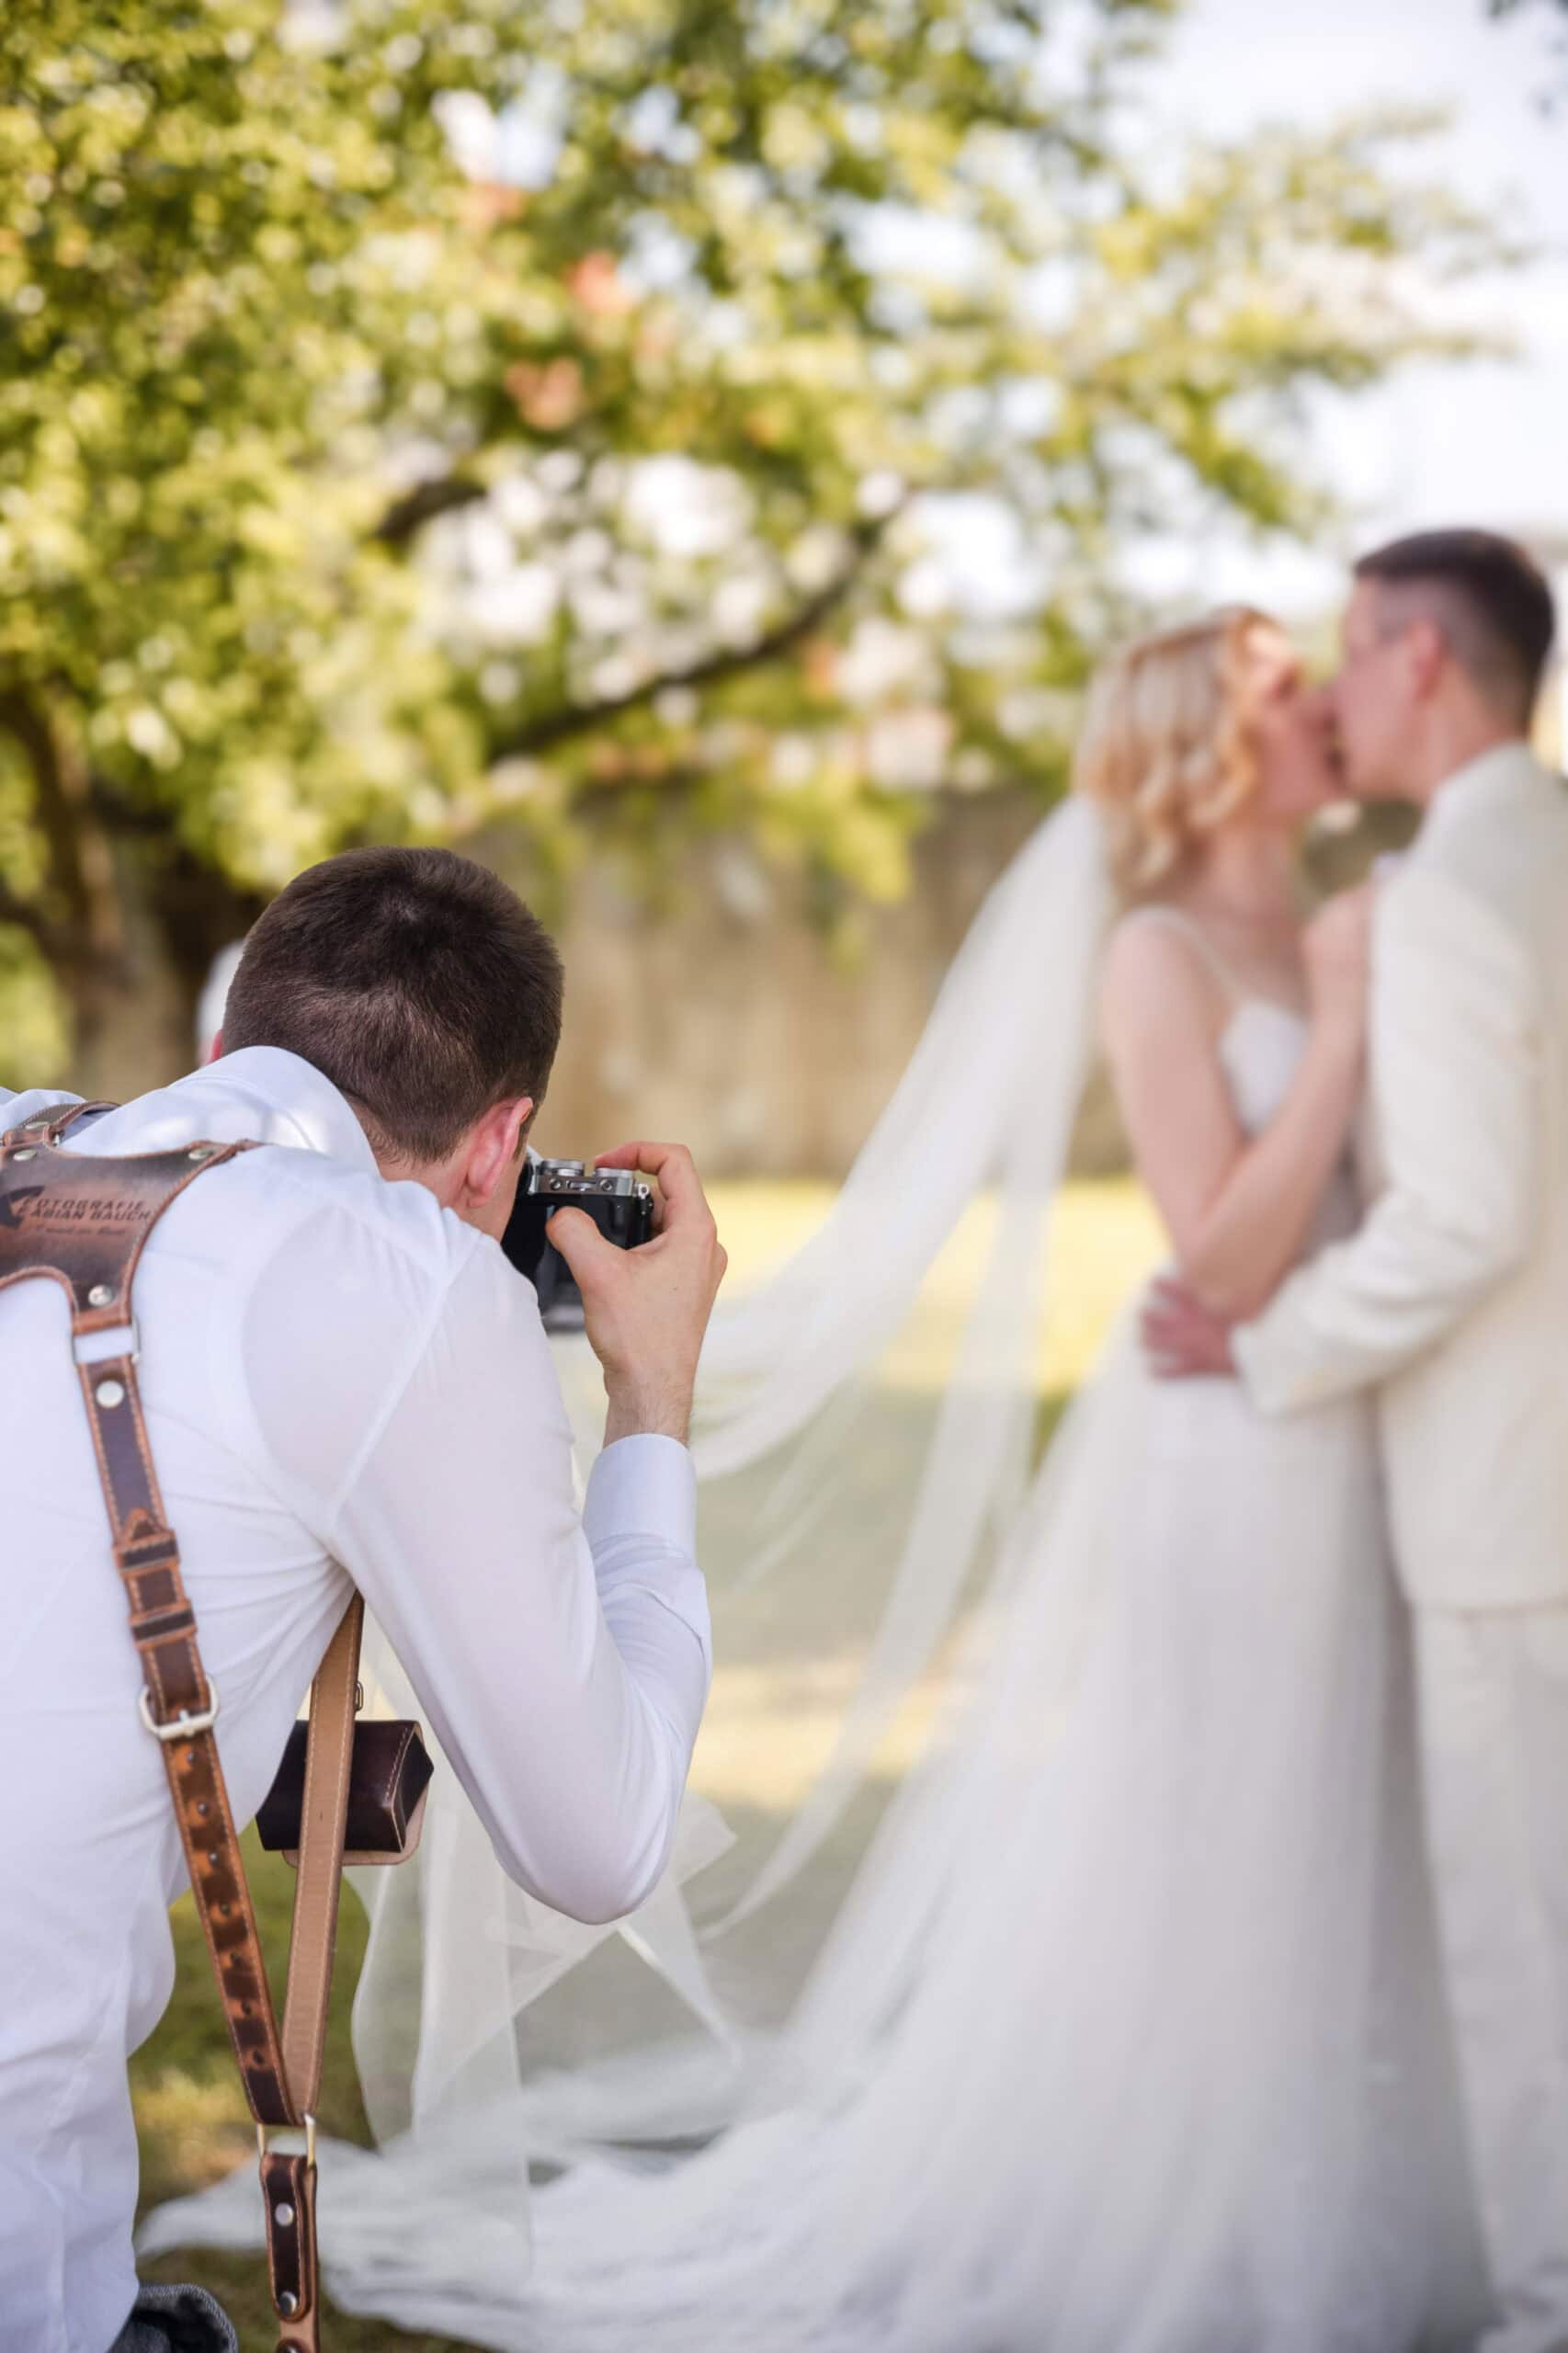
<box><xmin>143</xmin><ymin>851</ymin><xmax>1481</xmax><ymax>2353</ymax></box>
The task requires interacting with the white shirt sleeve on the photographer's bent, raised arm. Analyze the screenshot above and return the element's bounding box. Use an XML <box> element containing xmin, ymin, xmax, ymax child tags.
<box><xmin>306</xmin><ymin>1247</ymin><xmax>711</xmax><ymax>1920</ymax></box>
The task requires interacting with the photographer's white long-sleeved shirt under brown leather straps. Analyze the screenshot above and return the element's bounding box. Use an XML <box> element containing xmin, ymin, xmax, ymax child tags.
<box><xmin>0</xmin><ymin>1047</ymin><xmax>709</xmax><ymax>2353</ymax></box>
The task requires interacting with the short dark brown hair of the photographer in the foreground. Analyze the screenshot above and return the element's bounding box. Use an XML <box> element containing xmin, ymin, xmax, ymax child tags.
<box><xmin>223</xmin><ymin>847</ymin><xmax>562</xmax><ymax>1160</ymax></box>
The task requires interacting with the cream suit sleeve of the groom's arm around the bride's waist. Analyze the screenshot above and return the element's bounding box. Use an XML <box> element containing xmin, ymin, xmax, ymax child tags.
<box><xmin>1233</xmin><ymin>866</ymin><xmax>1542</xmax><ymax>1415</ymax></box>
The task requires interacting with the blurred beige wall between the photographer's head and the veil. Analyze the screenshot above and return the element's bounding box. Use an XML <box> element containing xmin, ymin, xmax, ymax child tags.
<box><xmin>501</xmin><ymin>790</ymin><xmax>1119</xmax><ymax>1184</ymax></box>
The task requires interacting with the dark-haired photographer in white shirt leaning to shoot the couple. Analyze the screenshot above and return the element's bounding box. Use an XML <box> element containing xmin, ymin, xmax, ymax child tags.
<box><xmin>0</xmin><ymin>849</ymin><xmax>725</xmax><ymax>2353</ymax></box>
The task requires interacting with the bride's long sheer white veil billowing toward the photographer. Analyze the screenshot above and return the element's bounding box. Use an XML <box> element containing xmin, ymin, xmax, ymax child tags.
<box><xmin>143</xmin><ymin>800</ymin><xmax>1111</xmax><ymax>2268</ymax></box>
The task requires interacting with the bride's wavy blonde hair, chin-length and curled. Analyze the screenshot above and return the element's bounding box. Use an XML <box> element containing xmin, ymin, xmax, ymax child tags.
<box><xmin>1074</xmin><ymin>605</ymin><xmax>1278</xmax><ymax>899</ymax></box>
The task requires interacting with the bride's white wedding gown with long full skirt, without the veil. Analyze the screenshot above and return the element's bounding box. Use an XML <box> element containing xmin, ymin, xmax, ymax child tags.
<box><xmin>268</xmin><ymin>978</ymin><xmax>1479</xmax><ymax>2353</ymax></box>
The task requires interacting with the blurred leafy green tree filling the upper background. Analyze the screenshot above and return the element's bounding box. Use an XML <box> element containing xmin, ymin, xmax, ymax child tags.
<box><xmin>0</xmin><ymin>0</ymin><xmax>1485</xmax><ymax>1063</ymax></box>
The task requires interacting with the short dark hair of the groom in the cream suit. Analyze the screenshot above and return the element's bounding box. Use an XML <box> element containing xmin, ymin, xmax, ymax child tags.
<box><xmin>1356</xmin><ymin>532</ymin><xmax>1556</xmax><ymax>727</ymax></box>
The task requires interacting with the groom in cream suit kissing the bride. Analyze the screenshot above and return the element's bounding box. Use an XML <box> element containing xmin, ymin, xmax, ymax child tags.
<box><xmin>1144</xmin><ymin>532</ymin><xmax>1568</xmax><ymax>2353</ymax></box>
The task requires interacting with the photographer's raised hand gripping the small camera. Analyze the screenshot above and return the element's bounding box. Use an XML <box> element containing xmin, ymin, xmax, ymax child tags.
<box><xmin>549</xmin><ymin>1143</ymin><xmax>728</xmax><ymax>1445</ymax></box>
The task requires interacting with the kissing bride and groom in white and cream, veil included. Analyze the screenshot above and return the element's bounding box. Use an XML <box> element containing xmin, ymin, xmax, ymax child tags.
<box><xmin>149</xmin><ymin>529</ymin><xmax>1568</xmax><ymax>2353</ymax></box>
